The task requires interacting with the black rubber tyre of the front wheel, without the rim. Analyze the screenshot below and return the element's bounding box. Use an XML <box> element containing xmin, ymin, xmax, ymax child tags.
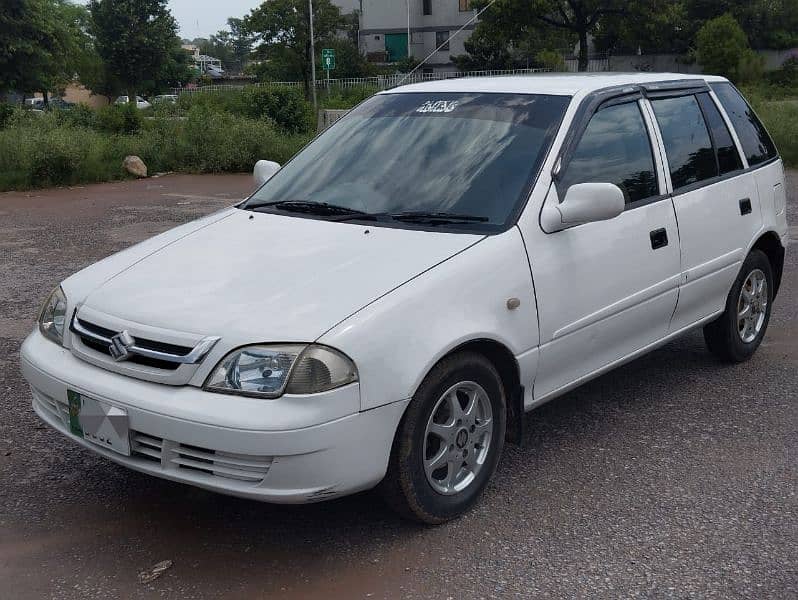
<box><xmin>380</xmin><ymin>352</ymin><xmax>507</xmax><ymax>525</ymax></box>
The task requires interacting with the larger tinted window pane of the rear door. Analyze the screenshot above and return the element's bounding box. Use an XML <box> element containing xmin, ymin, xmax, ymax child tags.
<box><xmin>651</xmin><ymin>96</ymin><xmax>718</xmax><ymax>189</ymax></box>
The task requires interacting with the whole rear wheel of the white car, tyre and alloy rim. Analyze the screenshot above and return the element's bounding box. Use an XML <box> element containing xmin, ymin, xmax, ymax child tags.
<box><xmin>704</xmin><ymin>250</ymin><xmax>773</xmax><ymax>362</ymax></box>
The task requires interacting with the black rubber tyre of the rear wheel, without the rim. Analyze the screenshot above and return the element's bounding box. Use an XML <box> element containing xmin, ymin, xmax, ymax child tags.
<box><xmin>704</xmin><ymin>250</ymin><xmax>773</xmax><ymax>363</ymax></box>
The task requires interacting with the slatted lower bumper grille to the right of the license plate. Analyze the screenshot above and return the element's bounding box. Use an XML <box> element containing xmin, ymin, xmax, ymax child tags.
<box><xmin>130</xmin><ymin>431</ymin><xmax>273</xmax><ymax>485</ymax></box>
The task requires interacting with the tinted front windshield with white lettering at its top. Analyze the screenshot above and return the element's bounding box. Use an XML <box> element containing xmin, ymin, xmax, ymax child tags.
<box><xmin>242</xmin><ymin>93</ymin><xmax>570</xmax><ymax>231</ymax></box>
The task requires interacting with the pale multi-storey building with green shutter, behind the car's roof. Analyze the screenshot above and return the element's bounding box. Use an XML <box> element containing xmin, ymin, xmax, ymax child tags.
<box><xmin>333</xmin><ymin>0</ymin><xmax>476</xmax><ymax>72</ymax></box>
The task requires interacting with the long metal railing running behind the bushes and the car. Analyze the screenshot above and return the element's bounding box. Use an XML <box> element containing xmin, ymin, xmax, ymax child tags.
<box><xmin>172</xmin><ymin>69</ymin><xmax>548</xmax><ymax>94</ymax></box>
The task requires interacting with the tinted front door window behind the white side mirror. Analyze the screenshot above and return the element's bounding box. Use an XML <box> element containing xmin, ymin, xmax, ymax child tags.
<box><xmin>561</xmin><ymin>102</ymin><xmax>659</xmax><ymax>203</ymax></box>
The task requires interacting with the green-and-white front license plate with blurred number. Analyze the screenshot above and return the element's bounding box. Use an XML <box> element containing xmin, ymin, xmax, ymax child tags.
<box><xmin>67</xmin><ymin>390</ymin><xmax>130</xmax><ymax>456</ymax></box>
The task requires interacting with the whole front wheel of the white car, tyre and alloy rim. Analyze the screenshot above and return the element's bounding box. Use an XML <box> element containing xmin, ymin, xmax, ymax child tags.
<box><xmin>380</xmin><ymin>352</ymin><xmax>506</xmax><ymax>524</ymax></box>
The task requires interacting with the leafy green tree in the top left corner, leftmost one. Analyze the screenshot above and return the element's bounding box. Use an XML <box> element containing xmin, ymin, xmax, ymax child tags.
<box><xmin>0</xmin><ymin>0</ymin><xmax>87</xmax><ymax>102</ymax></box>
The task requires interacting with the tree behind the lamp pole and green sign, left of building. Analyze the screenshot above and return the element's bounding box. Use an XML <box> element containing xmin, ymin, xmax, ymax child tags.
<box><xmin>244</xmin><ymin>0</ymin><xmax>342</xmax><ymax>90</ymax></box>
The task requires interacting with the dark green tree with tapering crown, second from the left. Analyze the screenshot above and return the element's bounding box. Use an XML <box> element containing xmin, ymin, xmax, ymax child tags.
<box><xmin>89</xmin><ymin>0</ymin><xmax>180</xmax><ymax>103</ymax></box>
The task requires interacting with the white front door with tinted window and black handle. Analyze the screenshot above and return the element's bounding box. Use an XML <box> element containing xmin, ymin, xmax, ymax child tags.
<box><xmin>522</xmin><ymin>96</ymin><xmax>680</xmax><ymax>402</ymax></box>
